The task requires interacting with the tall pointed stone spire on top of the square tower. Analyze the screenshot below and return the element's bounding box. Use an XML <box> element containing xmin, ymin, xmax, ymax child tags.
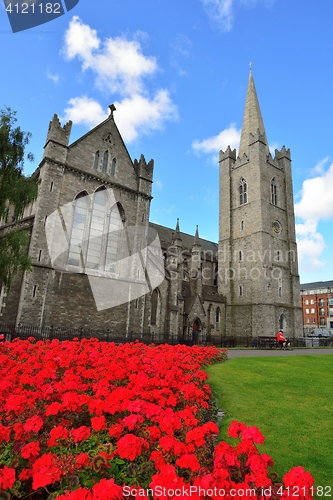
<box><xmin>238</xmin><ymin>67</ymin><xmax>268</xmax><ymax>156</ymax></box>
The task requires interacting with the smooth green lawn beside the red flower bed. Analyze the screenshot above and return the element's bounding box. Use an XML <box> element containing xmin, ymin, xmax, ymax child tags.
<box><xmin>207</xmin><ymin>355</ymin><xmax>333</xmax><ymax>488</ymax></box>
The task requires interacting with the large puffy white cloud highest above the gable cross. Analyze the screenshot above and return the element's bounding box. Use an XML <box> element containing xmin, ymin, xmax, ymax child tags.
<box><xmin>64</xmin><ymin>16</ymin><xmax>157</xmax><ymax>95</ymax></box>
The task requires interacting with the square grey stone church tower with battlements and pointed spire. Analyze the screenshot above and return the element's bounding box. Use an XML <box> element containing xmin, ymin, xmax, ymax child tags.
<box><xmin>218</xmin><ymin>70</ymin><xmax>302</xmax><ymax>337</ymax></box>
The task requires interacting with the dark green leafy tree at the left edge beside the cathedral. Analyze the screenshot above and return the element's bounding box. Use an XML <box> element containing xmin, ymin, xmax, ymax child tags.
<box><xmin>0</xmin><ymin>108</ymin><xmax>39</xmax><ymax>292</ymax></box>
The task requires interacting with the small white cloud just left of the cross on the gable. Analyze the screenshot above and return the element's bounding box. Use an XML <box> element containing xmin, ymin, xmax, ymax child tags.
<box><xmin>61</xmin><ymin>96</ymin><xmax>108</xmax><ymax>127</ymax></box>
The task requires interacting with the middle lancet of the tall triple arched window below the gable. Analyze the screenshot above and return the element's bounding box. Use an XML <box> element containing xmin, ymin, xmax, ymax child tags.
<box><xmin>86</xmin><ymin>189</ymin><xmax>106</xmax><ymax>269</ymax></box>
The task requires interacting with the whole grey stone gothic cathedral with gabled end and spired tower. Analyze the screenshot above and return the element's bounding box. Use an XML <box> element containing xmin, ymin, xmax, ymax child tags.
<box><xmin>0</xmin><ymin>71</ymin><xmax>302</xmax><ymax>342</ymax></box>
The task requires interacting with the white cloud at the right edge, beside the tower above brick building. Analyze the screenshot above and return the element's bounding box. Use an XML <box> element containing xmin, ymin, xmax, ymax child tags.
<box><xmin>295</xmin><ymin>158</ymin><xmax>333</xmax><ymax>272</ymax></box>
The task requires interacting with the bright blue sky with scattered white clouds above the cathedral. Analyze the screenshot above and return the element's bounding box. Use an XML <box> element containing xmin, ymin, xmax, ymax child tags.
<box><xmin>0</xmin><ymin>0</ymin><xmax>333</xmax><ymax>283</ymax></box>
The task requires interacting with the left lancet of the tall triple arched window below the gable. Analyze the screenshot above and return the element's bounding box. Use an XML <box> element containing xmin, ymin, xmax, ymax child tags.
<box><xmin>68</xmin><ymin>191</ymin><xmax>89</xmax><ymax>266</ymax></box>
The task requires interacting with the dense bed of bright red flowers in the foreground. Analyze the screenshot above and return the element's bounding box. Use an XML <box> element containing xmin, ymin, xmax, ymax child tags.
<box><xmin>0</xmin><ymin>339</ymin><xmax>314</xmax><ymax>500</ymax></box>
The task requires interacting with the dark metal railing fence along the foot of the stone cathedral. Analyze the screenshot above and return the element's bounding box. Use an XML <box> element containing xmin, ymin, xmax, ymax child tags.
<box><xmin>0</xmin><ymin>324</ymin><xmax>333</xmax><ymax>349</ymax></box>
